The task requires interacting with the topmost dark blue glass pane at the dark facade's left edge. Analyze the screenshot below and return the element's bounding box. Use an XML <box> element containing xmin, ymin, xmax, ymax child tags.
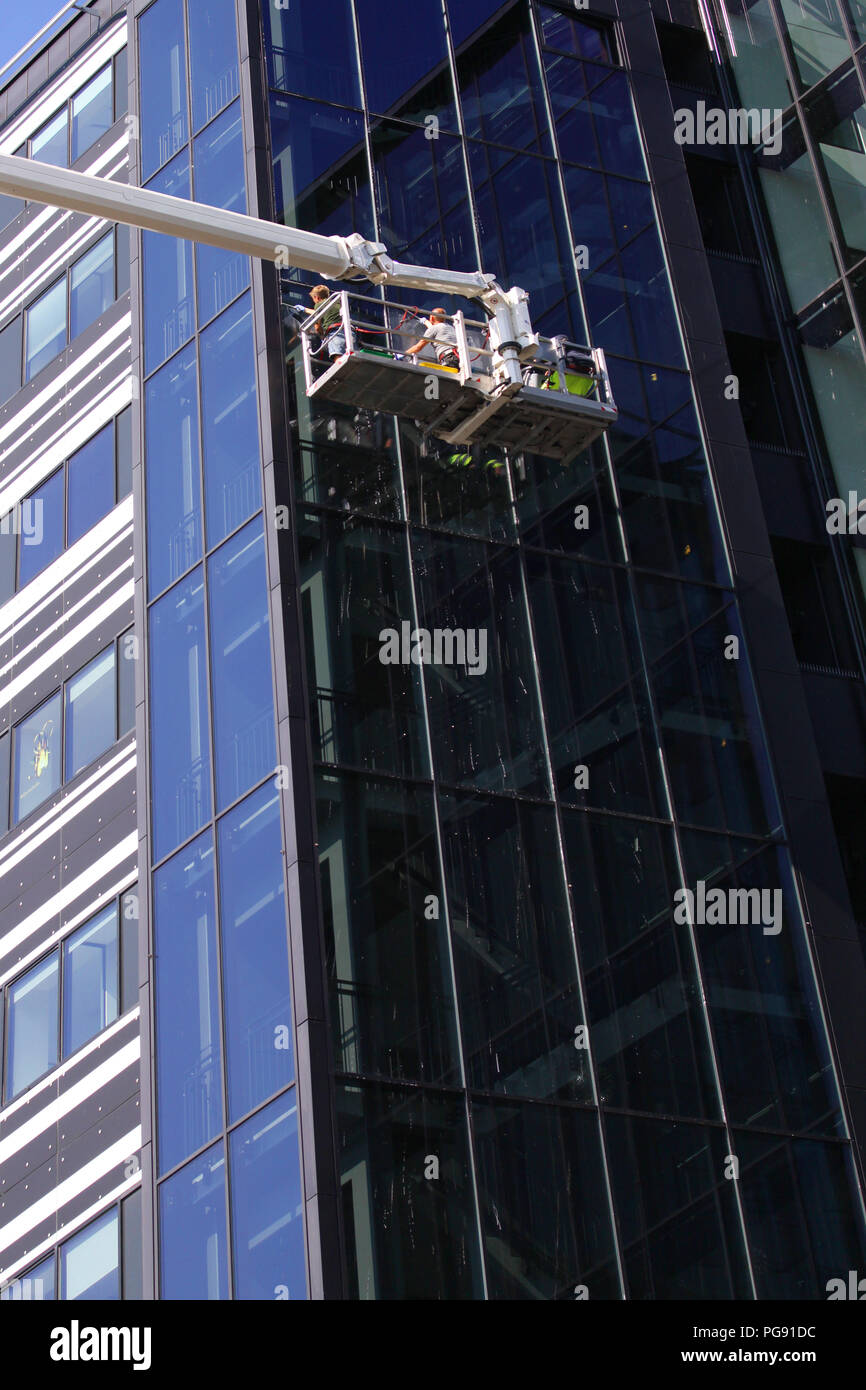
<box><xmin>261</xmin><ymin>0</ymin><xmax>361</xmax><ymax>106</ymax></box>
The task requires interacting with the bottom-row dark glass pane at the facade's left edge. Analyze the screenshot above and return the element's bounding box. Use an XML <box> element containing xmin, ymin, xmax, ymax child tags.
<box><xmin>336</xmin><ymin>1086</ymin><xmax>481</xmax><ymax>1300</ymax></box>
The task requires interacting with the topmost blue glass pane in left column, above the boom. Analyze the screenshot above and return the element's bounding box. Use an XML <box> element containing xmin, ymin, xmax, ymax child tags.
<box><xmin>139</xmin><ymin>0</ymin><xmax>189</xmax><ymax>179</ymax></box>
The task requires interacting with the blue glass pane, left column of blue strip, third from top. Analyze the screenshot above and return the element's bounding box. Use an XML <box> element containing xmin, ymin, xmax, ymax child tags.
<box><xmin>145</xmin><ymin>343</ymin><xmax>202</xmax><ymax>596</ymax></box>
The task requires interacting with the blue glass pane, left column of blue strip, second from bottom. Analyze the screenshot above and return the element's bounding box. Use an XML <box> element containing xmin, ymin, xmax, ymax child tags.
<box><xmin>153</xmin><ymin>833</ymin><xmax>222</xmax><ymax>1172</ymax></box>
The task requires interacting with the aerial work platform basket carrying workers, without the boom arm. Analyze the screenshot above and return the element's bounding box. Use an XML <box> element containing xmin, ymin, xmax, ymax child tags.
<box><xmin>299</xmin><ymin>291</ymin><xmax>617</xmax><ymax>460</ymax></box>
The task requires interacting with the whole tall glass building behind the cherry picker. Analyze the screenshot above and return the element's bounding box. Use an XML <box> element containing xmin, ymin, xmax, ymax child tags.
<box><xmin>0</xmin><ymin>0</ymin><xmax>866</xmax><ymax>1301</ymax></box>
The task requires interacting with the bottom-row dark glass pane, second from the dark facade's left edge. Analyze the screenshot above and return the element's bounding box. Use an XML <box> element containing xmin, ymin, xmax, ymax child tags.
<box><xmin>473</xmin><ymin>1101</ymin><xmax>620</xmax><ymax>1301</ymax></box>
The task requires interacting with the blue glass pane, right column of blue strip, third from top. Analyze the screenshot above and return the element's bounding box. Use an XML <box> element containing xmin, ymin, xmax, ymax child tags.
<box><xmin>200</xmin><ymin>295</ymin><xmax>261</xmax><ymax>546</ymax></box>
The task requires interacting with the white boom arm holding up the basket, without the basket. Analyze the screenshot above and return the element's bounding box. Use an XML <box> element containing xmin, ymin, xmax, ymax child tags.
<box><xmin>0</xmin><ymin>154</ymin><xmax>538</xmax><ymax>384</ymax></box>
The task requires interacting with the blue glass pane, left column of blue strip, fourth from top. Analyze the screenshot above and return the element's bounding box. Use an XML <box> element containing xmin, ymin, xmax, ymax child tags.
<box><xmin>150</xmin><ymin>564</ymin><xmax>213</xmax><ymax>859</ymax></box>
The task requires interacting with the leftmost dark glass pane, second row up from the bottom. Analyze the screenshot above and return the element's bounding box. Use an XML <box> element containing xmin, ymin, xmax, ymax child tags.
<box><xmin>317</xmin><ymin>774</ymin><xmax>457</xmax><ymax>1083</ymax></box>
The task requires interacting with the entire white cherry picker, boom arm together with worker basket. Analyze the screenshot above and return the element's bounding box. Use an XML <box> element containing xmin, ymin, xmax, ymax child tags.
<box><xmin>0</xmin><ymin>154</ymin><xmax>617</xmax><ymax>459</ymax></box>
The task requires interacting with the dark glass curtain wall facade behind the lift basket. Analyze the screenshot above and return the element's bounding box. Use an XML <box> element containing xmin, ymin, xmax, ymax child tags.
<box><xmin>265</xmin><ymin>0</ymin><xmax>863</xmax><ymax>1300</ymax></box>
